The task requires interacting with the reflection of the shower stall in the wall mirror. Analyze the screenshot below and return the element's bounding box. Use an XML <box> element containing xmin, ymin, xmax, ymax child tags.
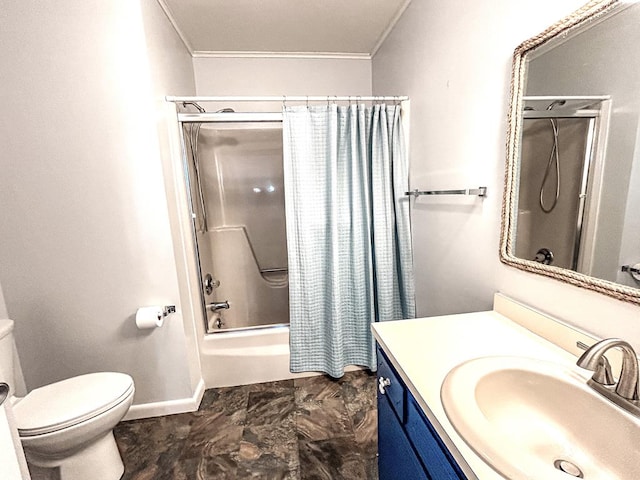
<box><xmin>515</xmin><ymin>97</ymin><xmax>614</xmax><ymax>274</ymax></box>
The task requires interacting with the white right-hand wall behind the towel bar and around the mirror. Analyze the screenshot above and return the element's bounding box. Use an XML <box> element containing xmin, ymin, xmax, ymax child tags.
<box><xmin>373</xmin><ymin>0</ymin><xmax>640</xmax><ymax>347</ymax></box>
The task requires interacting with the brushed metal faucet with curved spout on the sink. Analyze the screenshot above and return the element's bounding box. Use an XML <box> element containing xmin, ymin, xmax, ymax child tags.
<box><xmin>576</xmin><ymin>338</ymin><xmax>640</xmax><ymax>416</ymax></box>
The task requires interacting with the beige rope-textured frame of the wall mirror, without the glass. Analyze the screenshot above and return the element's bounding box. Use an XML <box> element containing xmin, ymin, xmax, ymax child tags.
<box><xmin>500</xmin><ymin>0</ymin><xmax>640</xmax><ymax>305</ymax></box>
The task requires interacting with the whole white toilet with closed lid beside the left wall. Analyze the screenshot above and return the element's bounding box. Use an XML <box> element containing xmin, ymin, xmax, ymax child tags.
<box><xmin>0</xmin><ymin>320</ymin><xmax>134</xmax><ymax>480</ymax></box>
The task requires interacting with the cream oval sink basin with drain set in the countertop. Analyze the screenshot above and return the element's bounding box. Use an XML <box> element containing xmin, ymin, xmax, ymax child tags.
<box><xmin>440</xmin><ymin>357</ymin><xmax>640</xmax><ymax>480</ymax></box>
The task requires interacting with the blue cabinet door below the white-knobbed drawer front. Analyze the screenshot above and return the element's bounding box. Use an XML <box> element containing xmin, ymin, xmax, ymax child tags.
<box><xmin>378</xmin><ymin>380</ymin><xmax>429</xmax><ymax>480</ymax></box>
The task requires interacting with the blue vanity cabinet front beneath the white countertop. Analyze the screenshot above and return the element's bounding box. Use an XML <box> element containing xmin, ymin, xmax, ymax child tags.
<box><xmin>378</xmin><ymin>347</ymin><xmax>467</xmax><ymax>480</ymax></box>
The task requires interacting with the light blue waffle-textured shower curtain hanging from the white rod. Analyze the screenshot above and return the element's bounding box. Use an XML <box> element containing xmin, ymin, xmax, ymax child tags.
<box><xmin>283</xmin><ymin>105</ymin><xmax>415</xmax><ymax>377</ymax></box>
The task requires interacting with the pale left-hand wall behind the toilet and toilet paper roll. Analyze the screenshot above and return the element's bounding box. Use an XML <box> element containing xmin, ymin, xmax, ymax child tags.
<box><xmin>0</xmin><ymin>0</ymin><xmax>199</xmax><ymax>404</ymax></box>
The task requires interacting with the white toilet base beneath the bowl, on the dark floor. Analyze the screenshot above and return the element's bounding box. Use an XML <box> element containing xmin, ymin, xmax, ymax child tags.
<box><xmin>25</xmin><ymin>431</ymin><xmax>124</xmax><ymax>480</ymax></box>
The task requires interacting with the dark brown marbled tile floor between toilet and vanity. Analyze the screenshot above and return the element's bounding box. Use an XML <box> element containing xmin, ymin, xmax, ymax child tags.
<box><xmin>114</xmin><ymin>370</ymin><xmax>378</xmax><ymax>480</ymax></box>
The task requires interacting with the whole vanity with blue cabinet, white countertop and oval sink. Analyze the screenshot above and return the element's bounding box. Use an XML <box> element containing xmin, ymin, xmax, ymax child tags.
<box><xmin>372</xmin><ymin>294</ymin><xmax>640</xmax><ymax>480</ymax></box>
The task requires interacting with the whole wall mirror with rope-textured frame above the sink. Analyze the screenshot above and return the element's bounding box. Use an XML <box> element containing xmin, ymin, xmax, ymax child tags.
<box><xmin>500</xmin><ymin>0</ymin><xmax>640</xmax><ymax>304</ymax></box>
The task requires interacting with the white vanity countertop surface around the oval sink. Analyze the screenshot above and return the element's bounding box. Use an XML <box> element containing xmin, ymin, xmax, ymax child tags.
<box><xmin>373</xmin><ymin>299</ymin><xmax>589</xmax><ymax>480</ymax></box>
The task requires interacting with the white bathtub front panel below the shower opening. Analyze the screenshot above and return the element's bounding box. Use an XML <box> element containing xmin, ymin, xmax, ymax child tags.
<box><xmin>200</xmin><ymin>326</ymin><xmax>315</xmax><ymax>388</ymax></box>
